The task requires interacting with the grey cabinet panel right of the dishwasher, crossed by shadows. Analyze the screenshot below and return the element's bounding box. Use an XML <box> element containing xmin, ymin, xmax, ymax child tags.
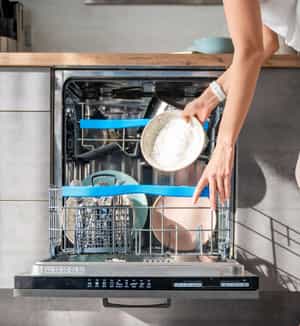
<box><xmin>236</xmin><ymin>69</ymin><xmax>300</xmax><ymax>291</ymax></box>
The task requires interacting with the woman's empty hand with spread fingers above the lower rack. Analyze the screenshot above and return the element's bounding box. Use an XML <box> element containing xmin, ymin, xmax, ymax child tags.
<box><xmin>193</xmin><ymin>143</ymin><xmax>234</xmax><ymax>210</ymax></box>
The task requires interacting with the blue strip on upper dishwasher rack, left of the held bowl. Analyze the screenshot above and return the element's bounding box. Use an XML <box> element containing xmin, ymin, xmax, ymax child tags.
<box><xmin>80</xmin><ymin>119</ymin><xmax>150</xmax><ymax>129</ymax></box>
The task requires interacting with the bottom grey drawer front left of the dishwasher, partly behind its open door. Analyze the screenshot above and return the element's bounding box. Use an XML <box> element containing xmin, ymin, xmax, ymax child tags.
<box><xmin>0</xmin><ymin>201</ymin><xmax>48</xmax><ymax>288</ymax></box>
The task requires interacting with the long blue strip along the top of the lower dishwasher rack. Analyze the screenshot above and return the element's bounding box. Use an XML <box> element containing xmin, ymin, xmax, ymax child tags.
<box><xmin>62</xmin><ymin>185</ymin><xmax>209</xmax><ymax>197</ymax></box>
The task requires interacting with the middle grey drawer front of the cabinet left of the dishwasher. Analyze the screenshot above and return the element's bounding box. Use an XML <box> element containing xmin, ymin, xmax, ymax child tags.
<box><xmin>0</xmin><ymin>111</ymin><xmax>50</xmax><ymax>200</ymax></box>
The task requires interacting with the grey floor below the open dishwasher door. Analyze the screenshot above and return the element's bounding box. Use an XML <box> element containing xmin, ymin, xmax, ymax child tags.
<box><xmin>0</xmin><ymin>290</ymin><xmax>300</xmax><ymax>326</ymax></box>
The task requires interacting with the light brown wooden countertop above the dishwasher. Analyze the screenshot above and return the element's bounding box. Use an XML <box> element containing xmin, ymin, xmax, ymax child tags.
<box><xmin>0</xmin><ymin>53</ymin><xmax>300</xmax><ymax>68</ymax></box>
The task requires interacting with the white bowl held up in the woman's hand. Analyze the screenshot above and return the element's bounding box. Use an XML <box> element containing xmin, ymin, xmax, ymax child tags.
<box><xmin>141</xmin><ymin>110</ymin><xmax>207</xmax><ymax>172</ymax></box>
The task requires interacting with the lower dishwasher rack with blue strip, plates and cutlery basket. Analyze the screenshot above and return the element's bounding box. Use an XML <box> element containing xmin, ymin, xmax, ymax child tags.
<box><xmin>49</xmin><ymin>185</ymin><xmax>233</xmax><ymax>259</ymax></box>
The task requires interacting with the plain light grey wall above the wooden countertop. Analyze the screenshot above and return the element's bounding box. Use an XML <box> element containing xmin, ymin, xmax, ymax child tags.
<box><xmin>22</xmin><ymin>0</ymin><xmax>227</xmax><ymax>52</ymax></box>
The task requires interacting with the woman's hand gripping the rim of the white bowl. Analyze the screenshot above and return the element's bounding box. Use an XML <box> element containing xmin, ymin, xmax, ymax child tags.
<box><xmin>182</xmin><ymin>87</ymin><xmax>219</xmax><ymax>123</ymax></box>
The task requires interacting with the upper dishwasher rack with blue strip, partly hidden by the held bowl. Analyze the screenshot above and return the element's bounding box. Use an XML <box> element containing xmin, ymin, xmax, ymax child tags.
<box><xmin>64</xmin><ymin>99</ymin><xmax>222</xmax><ymax>162</ymax></box>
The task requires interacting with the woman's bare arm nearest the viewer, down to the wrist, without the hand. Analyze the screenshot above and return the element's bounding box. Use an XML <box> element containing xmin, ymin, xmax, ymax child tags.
<box><xmin>217</xmin><ymin>0</ymin><xmax>264</xmax><ymax>146</ymax></box>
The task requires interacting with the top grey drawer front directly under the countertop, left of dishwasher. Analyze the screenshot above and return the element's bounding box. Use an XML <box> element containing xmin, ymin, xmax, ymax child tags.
<box><xmin>0</xmin><ymin>68</ymin><xmax>50</xmax><ymax>111</ymax></box>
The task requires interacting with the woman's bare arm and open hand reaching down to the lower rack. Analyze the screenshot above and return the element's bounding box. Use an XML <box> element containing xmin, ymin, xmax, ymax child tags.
<box><xmin>193</xmin><ymin>0</ymin><xmax>264</xmax><ymax>209</ymax></box>
